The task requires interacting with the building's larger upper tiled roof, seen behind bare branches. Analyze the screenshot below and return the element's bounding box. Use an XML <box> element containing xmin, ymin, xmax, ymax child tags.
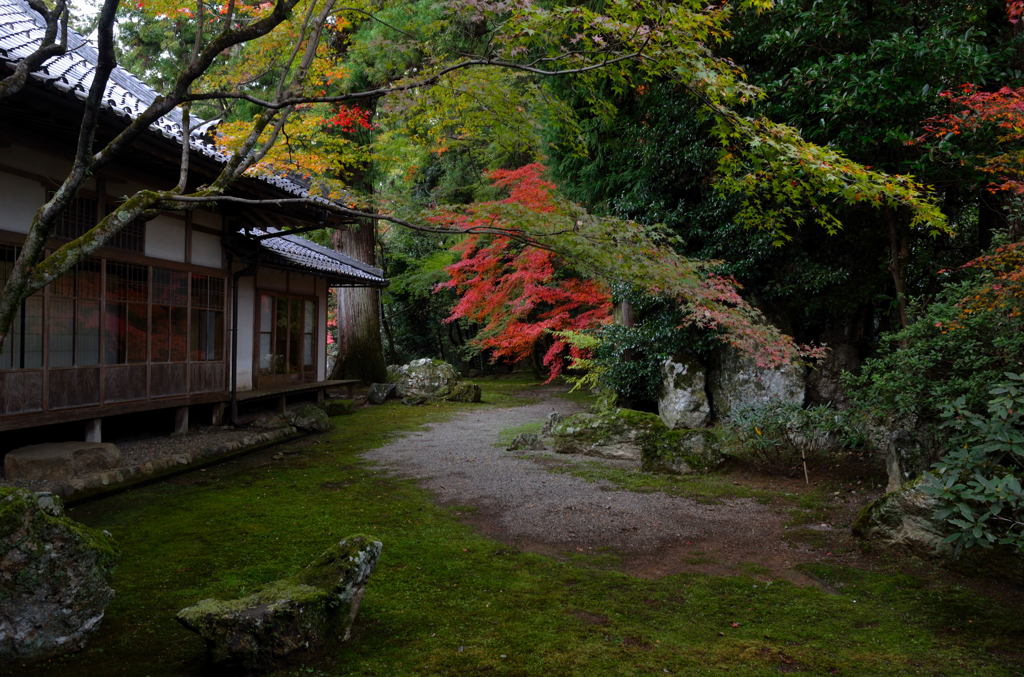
<box><xmin>0</xmin><ymin>0</ymin><xmax>327</xmax><ymax>202</ymax></box>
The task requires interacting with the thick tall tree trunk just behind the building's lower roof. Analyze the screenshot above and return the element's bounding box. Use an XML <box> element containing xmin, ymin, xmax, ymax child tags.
<box><xmin>331</xmin><ymin>221</ymin><xmax>387</xmax><ymax>383</ymax></box>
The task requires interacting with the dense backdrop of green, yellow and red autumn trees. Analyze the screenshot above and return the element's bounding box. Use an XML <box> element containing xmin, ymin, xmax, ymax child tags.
<box><xmin>81</xmin><ymin>0</ymin><xmax>1024</xmax><ymax>546</ymax></box>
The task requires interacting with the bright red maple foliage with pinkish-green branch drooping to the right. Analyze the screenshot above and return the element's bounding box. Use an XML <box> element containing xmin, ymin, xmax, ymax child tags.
<box><xmin>436</xmin><ymin>164</ymin><xmax>822</xmax><ymax>378</ymax></box>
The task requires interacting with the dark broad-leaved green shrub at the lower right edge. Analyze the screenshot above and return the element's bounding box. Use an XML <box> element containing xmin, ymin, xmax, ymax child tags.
<box><xmin>922</xmin><ymin>373</ymin><xmax>1024</xmax><ymax>553</ymax></box>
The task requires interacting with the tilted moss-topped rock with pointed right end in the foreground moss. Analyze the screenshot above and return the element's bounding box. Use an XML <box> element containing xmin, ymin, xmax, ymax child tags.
<box><xmin>177</xmin><ymin>536</ymin><xmax>381</xmax><ymax>673</ymax></box>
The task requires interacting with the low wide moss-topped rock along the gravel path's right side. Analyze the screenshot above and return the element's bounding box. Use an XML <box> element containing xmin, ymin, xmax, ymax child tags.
<box><xmin>549</xmin><ymin>409</ymin><xmax>724</xmax><ymax>473</ymax></box>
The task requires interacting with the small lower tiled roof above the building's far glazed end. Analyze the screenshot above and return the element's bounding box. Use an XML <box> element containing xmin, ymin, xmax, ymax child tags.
<box><xmin>240</xmin><ymin>227</ymin><xmax>387</xmax><ymax>287</ymax></box>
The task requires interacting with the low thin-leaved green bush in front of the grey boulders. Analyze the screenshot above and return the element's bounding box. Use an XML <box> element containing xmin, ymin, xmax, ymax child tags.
<box><xmin>728</xmin><ymin>400</ymin><xmax>865</xmax><ymax>474</ymax></box>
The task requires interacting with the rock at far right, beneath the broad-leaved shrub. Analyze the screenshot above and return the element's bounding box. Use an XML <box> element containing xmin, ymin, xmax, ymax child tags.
<box><xmin>853</xmin><ymin>479</ymin><xmax>953</xmax><ymax>557</ymax></box>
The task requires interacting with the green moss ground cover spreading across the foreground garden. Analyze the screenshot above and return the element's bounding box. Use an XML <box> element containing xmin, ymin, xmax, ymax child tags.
<box><xmin>18</xmin><ymin>380</ymin><xmax>1024</xmax><ymax>677</ymax></box>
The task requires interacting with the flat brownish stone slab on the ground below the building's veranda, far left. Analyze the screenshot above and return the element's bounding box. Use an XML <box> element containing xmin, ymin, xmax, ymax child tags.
<box><xmin>3</xmin><ymin>441</ymin><xmax>122</xmax><ymax>482</ymax></box>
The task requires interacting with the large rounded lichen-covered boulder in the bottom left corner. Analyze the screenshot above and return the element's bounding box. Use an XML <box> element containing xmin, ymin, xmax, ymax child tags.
<box><xmin>0</xmin><ymin>488</ymin><xmax>117</xmax><ymax>661</ymax></box>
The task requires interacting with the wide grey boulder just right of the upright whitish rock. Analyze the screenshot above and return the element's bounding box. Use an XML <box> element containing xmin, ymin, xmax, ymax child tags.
<box><xmin>710</xmin><ymin>347</ymin><xmax>805</xmax><ymax>419</ymax></box>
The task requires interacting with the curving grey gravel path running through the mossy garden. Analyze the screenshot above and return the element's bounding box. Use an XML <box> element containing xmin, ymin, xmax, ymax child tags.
<box><xmin>366</xmin><ymin>388</ymin><xmax>808</xmax><ymax>583</ymax></box>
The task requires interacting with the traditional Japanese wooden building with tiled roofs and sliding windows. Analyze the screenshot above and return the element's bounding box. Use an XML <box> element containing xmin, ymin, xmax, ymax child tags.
<box><xmin>0</xmin><ymin>0</ymin><xmax>386</xmax><ymax>439</ymax></box>
